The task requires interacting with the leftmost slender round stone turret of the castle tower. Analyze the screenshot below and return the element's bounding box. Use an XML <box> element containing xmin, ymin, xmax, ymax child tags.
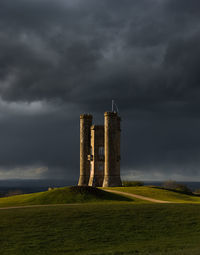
<box><xmin>78</xmin><ymin>114</ymin><xmax>92</xmax><ymax>186</ymax></box>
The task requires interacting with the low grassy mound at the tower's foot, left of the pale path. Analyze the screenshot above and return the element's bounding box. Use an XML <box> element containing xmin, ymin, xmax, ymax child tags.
<box><xmin>0</xmin><ymin>187</ymin><xmax>133</xmax><ymax>207</ymax></box>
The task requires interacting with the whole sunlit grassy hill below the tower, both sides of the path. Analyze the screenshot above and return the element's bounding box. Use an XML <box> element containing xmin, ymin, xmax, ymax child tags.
<box><xmin>0</xmin><ymin>186</ymin><xmax>200</xmax><ymax>208</ymax></box>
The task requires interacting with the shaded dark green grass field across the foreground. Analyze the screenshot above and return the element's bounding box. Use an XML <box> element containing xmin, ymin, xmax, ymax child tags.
<box><xmin>0</xmin><ymin>203</ymin><xmax>200</xmax><ymax>255</ymax></box>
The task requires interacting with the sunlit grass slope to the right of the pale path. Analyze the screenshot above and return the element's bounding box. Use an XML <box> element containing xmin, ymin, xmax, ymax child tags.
<box><xmin>109</xmin><ymin>186</ymin><xmax>200</xmax><ymax>203</ymax></box>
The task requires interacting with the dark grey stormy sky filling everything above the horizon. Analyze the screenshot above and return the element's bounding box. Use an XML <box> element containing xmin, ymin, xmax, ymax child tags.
<box><xmin>0</xmin><ymin>0</ymin><xmax>200</xmax><ymax>182</ymax></box>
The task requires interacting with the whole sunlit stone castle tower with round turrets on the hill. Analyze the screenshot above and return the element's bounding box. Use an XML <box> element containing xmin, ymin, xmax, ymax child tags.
<box><xmin>78</xmin><ymin>112</ymin><xmax>122</xmax><ymax>187</ymax></box>
